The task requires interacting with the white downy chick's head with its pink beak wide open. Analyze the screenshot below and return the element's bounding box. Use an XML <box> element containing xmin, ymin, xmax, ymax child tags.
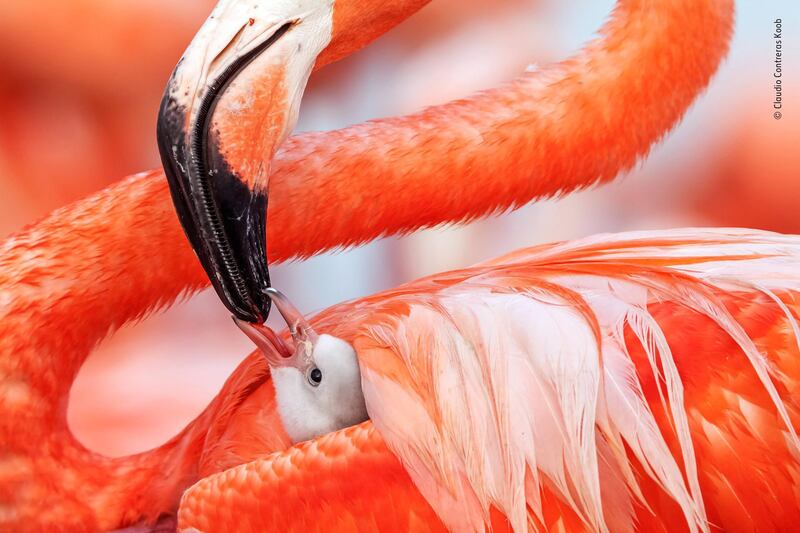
<box><xmin>234</xmin><ymin>289</ymin><xmax>367</xmax><ymax>442</ymax></box>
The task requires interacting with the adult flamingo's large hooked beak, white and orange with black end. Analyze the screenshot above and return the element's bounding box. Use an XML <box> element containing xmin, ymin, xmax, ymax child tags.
<box><xmin>158</xmin><ymin>0</ymin><xmax>333</xmax><ymax>323</ymax></box>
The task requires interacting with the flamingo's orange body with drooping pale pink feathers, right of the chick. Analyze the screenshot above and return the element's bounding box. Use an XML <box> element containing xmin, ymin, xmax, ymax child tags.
<box><xmin>179</xmin><ymin>230</ymin><xmax>800</xmax><ymax>531</ymax></box>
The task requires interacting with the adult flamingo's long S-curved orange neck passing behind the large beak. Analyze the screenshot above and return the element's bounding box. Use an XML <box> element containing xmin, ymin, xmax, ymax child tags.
<box><xmin>0</xmin><ymin>0</ymin><xmax>733</xmax><ymax>527</ymax></box>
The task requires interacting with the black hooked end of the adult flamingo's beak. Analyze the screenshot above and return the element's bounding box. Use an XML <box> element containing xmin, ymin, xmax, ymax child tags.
<box><xmin>157</xmin><ymin>88</ymin><xmax>271</xmax><ymax>323</ymax></box>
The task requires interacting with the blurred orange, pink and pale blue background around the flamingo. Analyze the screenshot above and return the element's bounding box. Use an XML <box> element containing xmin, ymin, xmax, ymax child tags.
<box><xmin>0</xmin><ymin>0</ymin><xmax>800</xmax><ymax>455</ymax></box>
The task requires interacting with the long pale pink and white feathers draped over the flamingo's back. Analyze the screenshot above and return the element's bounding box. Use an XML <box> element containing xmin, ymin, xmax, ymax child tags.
<box><xmin>356</xmin><ymin>230</ymin><xmax>800</xmax><ymax>531</ymax></box>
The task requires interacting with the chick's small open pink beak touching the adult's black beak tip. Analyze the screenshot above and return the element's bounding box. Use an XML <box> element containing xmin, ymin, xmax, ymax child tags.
<box><xmin>233</xmin><ymin>288</ymin><xmax>319</xmax><ymax>369</ymax></box>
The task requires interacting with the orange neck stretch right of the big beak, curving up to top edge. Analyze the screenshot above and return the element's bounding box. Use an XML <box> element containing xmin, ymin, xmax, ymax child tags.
<box><xmin>268</xmin><ymin>0</ymin><xmax>733</xmax><ymax>259</ymax></box>
